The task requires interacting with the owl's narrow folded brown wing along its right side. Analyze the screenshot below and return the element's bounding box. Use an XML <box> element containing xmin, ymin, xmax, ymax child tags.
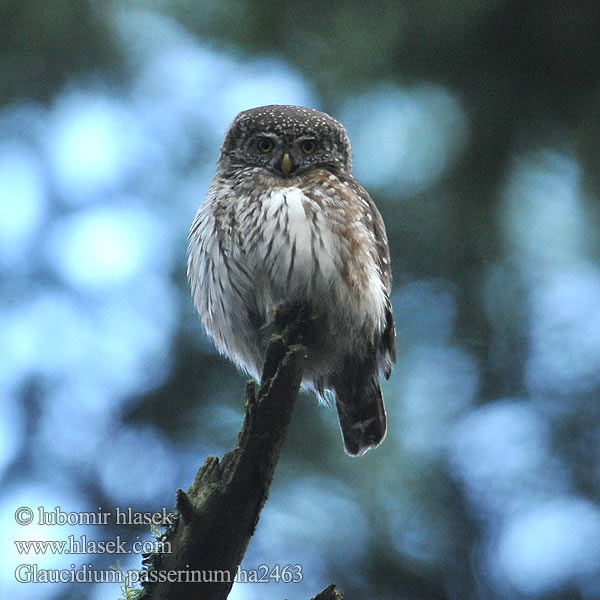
<box><xmin>349</xmin><ymin>180</ymin><xmax>396</xmax><ymax>379</ymax></box>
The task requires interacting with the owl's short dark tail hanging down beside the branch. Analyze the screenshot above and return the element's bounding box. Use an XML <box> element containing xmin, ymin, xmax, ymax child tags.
<box><xmin>335</xmin><ymin>372</ymin><xmax>387</xmax><ymax>456</ymax></box>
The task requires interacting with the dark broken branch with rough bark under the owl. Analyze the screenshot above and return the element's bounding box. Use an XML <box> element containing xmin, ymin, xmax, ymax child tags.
<box><xmin>136</xmin><ymin>322</ymin><xmax>342</xmax><ymax>600</ymax></box>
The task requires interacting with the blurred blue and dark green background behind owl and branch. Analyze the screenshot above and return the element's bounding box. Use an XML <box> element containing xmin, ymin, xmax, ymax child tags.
<box><xmin>0</xmin><ymin>0</ymin><xmax>600</xmax><ymax>600</ymax></box>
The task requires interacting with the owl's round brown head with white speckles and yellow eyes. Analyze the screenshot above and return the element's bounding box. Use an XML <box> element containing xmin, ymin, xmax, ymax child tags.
<box><xmin>219</xmin><ymin>104</ymin><xmax>352</xmax><ymax>178</ymax></box>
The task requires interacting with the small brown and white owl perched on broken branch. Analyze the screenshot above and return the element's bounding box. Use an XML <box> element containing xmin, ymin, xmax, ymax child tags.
<box><xmin>188</xmin><ymin>105</ymin><xmax>396</xmax><ymax>456</ymax></box>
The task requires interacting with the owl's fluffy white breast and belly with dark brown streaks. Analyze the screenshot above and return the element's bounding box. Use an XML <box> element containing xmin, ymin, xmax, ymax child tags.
<box><xmin>188</xmin><ymin>171</ymin><xmax>386</xmax><ymax>389</ymax></box>
